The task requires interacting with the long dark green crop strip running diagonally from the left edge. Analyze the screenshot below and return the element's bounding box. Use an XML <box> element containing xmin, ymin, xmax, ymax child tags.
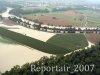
<box><xmin>0</xmin><ymin>27</ymin><xmax>71</xmax><ymax>54</ymax></box>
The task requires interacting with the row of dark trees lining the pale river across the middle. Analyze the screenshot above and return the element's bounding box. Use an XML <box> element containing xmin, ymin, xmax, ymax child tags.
<box><xmin>9</xmin><ymin>17</ymin><xmax>100</xmax><ymax>33</ymax></box>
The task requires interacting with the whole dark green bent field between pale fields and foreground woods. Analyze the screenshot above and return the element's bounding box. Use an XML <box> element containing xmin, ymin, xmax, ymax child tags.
<box><xmin>0</xmin><ymin>27</ymin><xmax>88</xmax><ymax>55</ymax></box>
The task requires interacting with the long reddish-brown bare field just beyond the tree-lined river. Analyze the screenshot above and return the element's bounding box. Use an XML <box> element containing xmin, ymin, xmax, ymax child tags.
<box><xmin>27</xmin><ymin>16</ymin><xmax>81</xmax><ymax>27</ymax></box>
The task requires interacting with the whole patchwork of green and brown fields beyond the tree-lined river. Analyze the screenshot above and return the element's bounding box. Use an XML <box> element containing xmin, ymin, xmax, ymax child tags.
<box><xmin>21</xmin><ymin>7</ymin><xmax>100</xmax><ymax>27</ymax></box>
